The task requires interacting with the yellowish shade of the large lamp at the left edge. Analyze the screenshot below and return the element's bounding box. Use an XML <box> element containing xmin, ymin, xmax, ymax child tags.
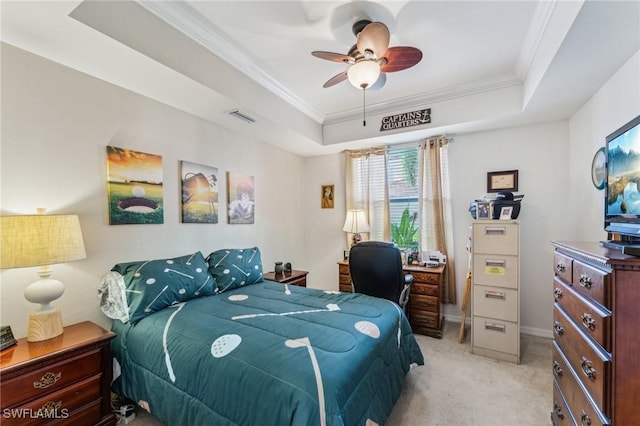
<box><xmin>0</xmin><ymin>215</ymin><xmax>87</xmax><ymax>269</ymax></box>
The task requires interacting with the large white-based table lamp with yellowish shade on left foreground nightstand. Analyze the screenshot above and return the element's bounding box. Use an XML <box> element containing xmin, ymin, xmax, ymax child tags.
<box><xmin>0</xmin><ymin>209</ymin><xmax>87</xmax><ymax>342</ymax></box>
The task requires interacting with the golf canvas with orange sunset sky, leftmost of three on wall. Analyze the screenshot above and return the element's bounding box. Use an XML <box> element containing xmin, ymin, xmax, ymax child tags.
<box><xmin>107</xmin><ymin>146</ymin><xmax>164</xmax><ymax>225</ymax></box>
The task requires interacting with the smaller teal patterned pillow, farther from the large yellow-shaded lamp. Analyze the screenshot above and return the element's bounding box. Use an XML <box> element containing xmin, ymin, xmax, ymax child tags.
<box><xmin>207</xmin><ymin>247</ymin><xmax>264</xmax><ymax>293</ymax></box>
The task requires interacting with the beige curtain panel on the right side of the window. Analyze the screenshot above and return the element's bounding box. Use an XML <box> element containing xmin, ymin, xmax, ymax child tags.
<box><xmin>419</xmin><ymin>136</ymin><xmax>456</xmax><ymax>304</ymax></box>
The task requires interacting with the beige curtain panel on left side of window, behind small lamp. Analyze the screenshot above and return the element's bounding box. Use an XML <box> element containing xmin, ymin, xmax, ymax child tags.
<box><xmin>345</xmin><ymin>147</ymin><xmax>391</xmax><ymax>247</ymax></box>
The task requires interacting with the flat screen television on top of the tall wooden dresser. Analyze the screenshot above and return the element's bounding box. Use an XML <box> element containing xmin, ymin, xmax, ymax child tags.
<box><xmin>604</xmin><ymin>115</ymin><xmax>640</xmax><ymax>248</ymax></box>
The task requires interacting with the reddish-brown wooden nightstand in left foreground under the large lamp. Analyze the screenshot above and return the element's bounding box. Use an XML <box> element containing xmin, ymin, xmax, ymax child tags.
<box><xmin>0</xmin><ymin>321</ymin><xmax>116</xmax><ymax>425</ymax></box>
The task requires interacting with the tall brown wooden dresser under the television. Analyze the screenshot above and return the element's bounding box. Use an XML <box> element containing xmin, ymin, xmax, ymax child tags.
<box><xmin>551</xmin><ymin>242</ymin><xmax>640</xmax><ymax>426</ymax></box>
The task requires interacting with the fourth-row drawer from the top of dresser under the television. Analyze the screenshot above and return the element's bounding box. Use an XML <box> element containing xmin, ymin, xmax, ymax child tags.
<box><xmin>553</xmin><ymin>345</ymin><xmax>610</xmax><ymax>426</ymax></box>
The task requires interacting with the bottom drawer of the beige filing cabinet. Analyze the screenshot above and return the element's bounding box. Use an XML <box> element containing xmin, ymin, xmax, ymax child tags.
<box><xmin>472</xmin><ymin>315</ymin><xmax>519</xmax><ymax>354</ymax></box>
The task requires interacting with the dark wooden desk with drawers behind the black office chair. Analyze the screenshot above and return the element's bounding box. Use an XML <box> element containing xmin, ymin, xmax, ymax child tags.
<box><xmin>338</xmin><ymin>260</ymin><xmax>445</xmax><ymax>339</ymax></box>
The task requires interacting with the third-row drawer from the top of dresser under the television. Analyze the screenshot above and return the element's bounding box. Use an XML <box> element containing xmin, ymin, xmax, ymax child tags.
<box><xmin>553</xmin><ymin>303</ymin><xmax>611</xmax><ymax>414</ymax></box>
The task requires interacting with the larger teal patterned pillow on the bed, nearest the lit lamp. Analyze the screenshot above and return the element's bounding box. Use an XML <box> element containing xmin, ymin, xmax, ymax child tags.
<box><xmin>111</xmin><ymin>252</ymin><xmax>215</xmax><ymax>324</ymax></box>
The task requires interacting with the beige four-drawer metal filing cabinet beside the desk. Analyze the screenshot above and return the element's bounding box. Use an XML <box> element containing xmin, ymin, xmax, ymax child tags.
<box><xmin>471</xmin><ymin>220</ymin><xmax>520</xmax><ymax>364</ymax></box>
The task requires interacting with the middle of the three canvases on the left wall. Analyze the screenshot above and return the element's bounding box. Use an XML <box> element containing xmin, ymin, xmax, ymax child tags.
<box><xmin>180</xmin><ymin>161</ymin><xmax>218</xmax><ymax>223</ymax></box>
